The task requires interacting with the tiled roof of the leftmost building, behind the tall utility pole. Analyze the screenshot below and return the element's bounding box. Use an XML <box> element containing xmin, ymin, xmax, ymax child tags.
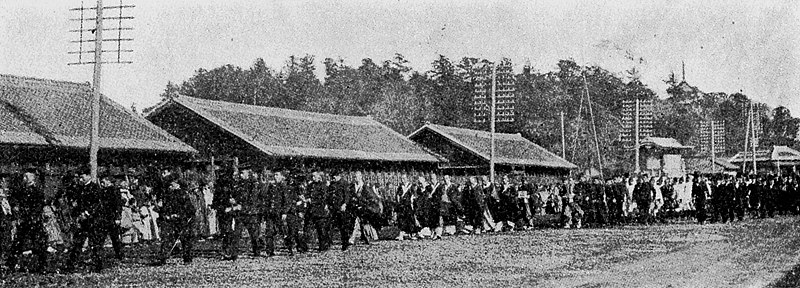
<box><xmin>0</xmin><ymin>74</ymin><xmax>197</xmax><ymax>153</ymax></box>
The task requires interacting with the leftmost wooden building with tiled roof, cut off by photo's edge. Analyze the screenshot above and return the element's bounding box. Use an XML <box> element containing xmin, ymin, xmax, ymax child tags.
<box><xmin>0</xmin><ymin>74</ymin><xmax>197</xmax><ymax>196</ymax></box>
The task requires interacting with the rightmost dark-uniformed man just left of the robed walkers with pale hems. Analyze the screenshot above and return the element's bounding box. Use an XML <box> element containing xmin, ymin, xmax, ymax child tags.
<box><xmin>328</xmin><ymin>171</ymin><xmax>355</xmax><ymax>251</ymax></box>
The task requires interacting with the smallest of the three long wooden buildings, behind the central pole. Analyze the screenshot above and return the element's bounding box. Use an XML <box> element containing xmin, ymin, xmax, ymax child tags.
<box><xmin>408</xmin><ymin>123</ymin><xmax>578</xmax><ymax>181</ymax></box>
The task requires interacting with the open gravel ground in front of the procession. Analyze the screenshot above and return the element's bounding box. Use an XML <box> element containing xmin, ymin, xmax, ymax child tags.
<box><xmin>0</xmin><ymin>216</ymin><xmax>800</xmax><ymax>287</ymax></box>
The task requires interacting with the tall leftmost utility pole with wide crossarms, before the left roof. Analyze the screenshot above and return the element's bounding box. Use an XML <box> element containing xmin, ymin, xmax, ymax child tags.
<box><xmin>67</xmin><ymin>0</ymin><xmax>134</xmax><ymax>182</ymax></box>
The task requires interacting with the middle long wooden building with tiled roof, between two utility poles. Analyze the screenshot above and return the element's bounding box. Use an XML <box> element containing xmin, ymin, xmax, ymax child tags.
<box><xmin>147</xmin><ymin>96</ymin><xmax>440</xmax><ymax>185</ymax></box>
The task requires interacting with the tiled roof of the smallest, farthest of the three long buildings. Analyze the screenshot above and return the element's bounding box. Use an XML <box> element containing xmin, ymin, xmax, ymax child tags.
<box><xmin>408</xmin><ymin>124</ymin><xmax>578</xmax><ymax>169</ymax></box>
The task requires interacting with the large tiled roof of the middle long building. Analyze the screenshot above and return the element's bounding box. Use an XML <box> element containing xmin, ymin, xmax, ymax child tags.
<box><xmin>148</xmin><ymin>96</ymin><xmax>439</xmax><ymax>162</ymax></box>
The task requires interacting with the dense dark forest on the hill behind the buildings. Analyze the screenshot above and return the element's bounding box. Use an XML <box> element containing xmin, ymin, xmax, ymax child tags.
<box><xmin>145</xmin><ymin>54</ymin><xmax>800</xmax><ymax>176</ymax></box>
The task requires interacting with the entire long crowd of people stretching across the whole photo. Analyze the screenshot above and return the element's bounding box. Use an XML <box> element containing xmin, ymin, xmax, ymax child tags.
<box><xmin>0</xmin><ymin>165</ymin><xmax>800</xmax><ymax>273</ymax></box>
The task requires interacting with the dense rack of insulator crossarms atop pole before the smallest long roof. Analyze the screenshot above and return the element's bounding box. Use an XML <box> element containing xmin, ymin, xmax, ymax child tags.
<box><xmin>472</xmin><ymin>59</ymin><xmax>516</xmax><ymax>123</ymax></box>
